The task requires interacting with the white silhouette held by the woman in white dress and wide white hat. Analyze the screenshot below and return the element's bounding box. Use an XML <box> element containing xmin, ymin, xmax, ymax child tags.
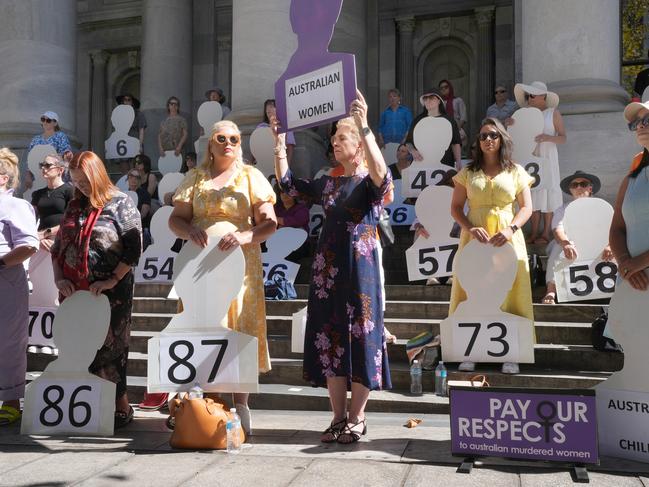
<box><xmin>507</xmin><ymin>107</ymin><xmax>547</xmax><ymax>189</ymax></box>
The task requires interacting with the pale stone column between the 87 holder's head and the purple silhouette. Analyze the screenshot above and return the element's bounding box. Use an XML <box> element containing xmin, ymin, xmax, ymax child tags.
<box><xmin>228</xmin><ymin>0</ymin><xmax>297</xmax><ymax>130</ymax></box>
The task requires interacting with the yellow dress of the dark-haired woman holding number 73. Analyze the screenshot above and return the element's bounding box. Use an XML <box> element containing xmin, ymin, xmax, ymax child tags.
<box><xmin>449</xmin><ymin>164</ymin><xmax>534</xmax><ymax>321</ymax></box>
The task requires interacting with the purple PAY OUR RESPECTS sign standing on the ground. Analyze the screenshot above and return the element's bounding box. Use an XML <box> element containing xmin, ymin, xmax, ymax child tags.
<box><xmin>449</xmin><ymin>387</ymin><xmax>599</xmax><ymax>463</ymax></box>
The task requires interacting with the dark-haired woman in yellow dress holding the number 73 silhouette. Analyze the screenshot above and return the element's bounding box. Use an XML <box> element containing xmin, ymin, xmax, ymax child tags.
<box><xmin>449</xmin><ymin>118</ymin><xmax>534</xmax><ymax>374</ymax></box>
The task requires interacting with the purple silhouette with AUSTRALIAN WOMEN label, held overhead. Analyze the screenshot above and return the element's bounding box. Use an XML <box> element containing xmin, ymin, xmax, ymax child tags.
<box><xmin>275</xmin><ymin>0</ymin><xmax>356</xmax><ymax>132</ymax></box>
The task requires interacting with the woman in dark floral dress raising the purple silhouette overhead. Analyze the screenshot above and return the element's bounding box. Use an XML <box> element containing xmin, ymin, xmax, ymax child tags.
<box><xmin>273</xmin><ymin>92</ymin><xmax>391</xmax><ymax>443</ymax></box>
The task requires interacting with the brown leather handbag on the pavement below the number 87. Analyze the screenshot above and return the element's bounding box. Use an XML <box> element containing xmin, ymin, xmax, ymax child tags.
<box><xmin>169</xmin><ymin>396</ymin><xmax>246</xmax><ymax>450</ymax></box>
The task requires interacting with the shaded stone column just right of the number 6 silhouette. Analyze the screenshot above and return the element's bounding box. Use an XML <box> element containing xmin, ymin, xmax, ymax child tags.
<box><xmin>140</xmin><ymin>0</ymin><xmax>193</xmax><ymax>158</ymax></box>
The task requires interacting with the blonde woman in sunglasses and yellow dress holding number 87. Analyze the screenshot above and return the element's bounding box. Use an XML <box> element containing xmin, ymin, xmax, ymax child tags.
<box><xmin>169</xmin><ymin>120</ymin><xmax>277</xmax><ymax>433</ymax></box>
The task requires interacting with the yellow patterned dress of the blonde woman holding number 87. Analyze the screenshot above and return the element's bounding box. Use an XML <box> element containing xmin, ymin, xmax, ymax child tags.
<box><xmin>174</xmin><ymin>166</ymin><xmax>275</xmax><ymax>372</ymax></box>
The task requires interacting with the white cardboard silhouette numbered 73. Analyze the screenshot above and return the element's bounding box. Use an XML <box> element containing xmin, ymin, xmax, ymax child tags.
<box><xmin>440</xmin><ymin>240</ymin><xmax>534</xmax><ymax>363</ymax></box>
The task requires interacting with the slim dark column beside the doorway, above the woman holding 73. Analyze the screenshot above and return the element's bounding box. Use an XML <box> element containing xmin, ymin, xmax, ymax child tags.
<box><xmin>471</xmin><ymin>6</ymin><xmax>495</xmax><ymax>127</ymax></box>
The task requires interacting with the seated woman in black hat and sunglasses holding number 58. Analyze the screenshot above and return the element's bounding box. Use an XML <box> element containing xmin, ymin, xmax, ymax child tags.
<box><xmin>542</xmin><ymin>171</ymin><xmax>613</xmax><ymax>304</ymax></box>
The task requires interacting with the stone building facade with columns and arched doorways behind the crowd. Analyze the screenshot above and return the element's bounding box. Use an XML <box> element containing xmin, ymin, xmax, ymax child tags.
<box><xmin>0</xmin><ymin>0</ymin><xmax>638</xmax><ymax>199</ymax></box>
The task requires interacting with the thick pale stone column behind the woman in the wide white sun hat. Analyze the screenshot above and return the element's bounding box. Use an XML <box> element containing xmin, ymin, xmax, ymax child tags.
<box><xmin>520</xmin><ymin>0</ymin><xmax>628</xmax><ymax>114</ymax></box>
